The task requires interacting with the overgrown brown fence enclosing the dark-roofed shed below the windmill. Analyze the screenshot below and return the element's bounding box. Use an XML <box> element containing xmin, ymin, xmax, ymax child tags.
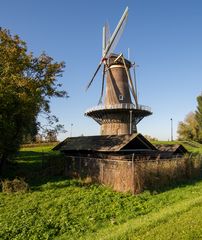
<box><xmin>65</xmin><ymin>155</ymin><xmax>202</xmax><ymax>194</ymax></box>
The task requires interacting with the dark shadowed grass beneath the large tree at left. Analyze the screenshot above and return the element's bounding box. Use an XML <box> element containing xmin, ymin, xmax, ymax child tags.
<box><xmin>1</xmin><ymin>151</ymin><xmax>67</xmax><ymax>188</ymax></box>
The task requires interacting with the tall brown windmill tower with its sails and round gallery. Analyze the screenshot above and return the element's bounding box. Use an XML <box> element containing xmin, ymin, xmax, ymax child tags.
<box><xmin>85</xmin><ymin>7</ymin><xmax>152</xmax><ymax>135</ymax></box>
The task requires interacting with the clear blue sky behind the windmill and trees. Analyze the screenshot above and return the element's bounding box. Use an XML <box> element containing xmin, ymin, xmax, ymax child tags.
<box><xmin>0</xmin><ymin>0</ymin><xmax>202</xmax><ymax>140</ymax></box>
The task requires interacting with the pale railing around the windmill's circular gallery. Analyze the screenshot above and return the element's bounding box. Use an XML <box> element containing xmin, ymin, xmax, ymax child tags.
<box><xmin>86</xmin><ymin>103</ymin><xmax>151</xmax><ymax>113</ymax></box>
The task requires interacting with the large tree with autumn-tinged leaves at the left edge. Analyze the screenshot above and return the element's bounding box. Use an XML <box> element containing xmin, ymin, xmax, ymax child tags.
<box><xmin>0</xmin><ymin>28</ymin><xmax>67</xmax><ymax>169</ymax></box>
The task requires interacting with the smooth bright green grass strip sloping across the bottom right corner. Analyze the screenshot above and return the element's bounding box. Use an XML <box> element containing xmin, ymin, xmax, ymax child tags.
<box><xmin>89</xmin><ymin>197</ymin><xmax>202</xmax><ymax>240</ymax></box>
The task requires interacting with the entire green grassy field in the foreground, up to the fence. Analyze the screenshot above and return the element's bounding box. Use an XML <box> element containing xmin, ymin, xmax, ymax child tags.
<box><xmin>0</xmin><ymin>143</ymin><xmax>202</xmax><ymax>240</ymax></box>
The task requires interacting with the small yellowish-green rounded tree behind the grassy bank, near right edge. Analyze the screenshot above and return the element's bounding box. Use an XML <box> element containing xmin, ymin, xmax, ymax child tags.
<box><xmin>177</xmin><ymin>112</ymin><xmax>199</xmax><ymax>141</ymax></box>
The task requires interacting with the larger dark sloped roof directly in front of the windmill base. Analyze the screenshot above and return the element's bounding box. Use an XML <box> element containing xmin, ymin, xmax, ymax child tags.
<box><xmin>53</xmin><ymin>133</ymin><xmax>156</xmax><ymax>152</ymax></box>
